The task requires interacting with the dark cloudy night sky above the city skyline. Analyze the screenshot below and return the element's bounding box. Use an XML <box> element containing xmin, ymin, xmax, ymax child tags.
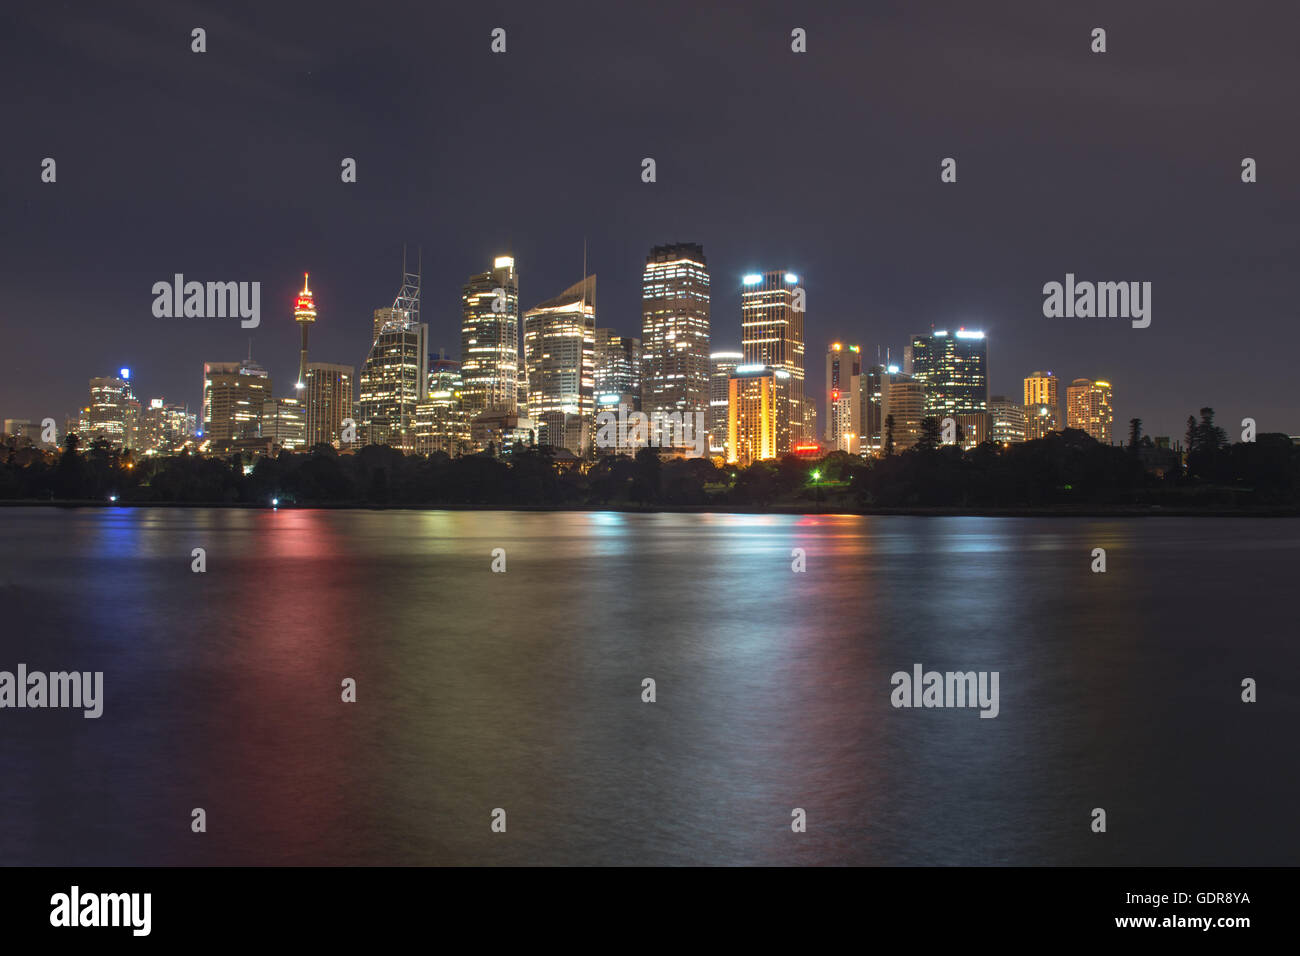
<box><xmin>0</xmin><ymin>0</ymin><xmax>1300</xmax><ymax>437</ymax></box>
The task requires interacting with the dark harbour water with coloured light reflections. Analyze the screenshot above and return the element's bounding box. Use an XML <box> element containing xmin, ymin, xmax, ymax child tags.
<box><xmin>0</xmin><ymin>509</ymin><xmax>1300</xmax><ymax>865</ymax></box>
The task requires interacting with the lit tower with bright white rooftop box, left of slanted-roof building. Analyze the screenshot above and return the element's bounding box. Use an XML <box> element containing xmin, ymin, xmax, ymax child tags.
<box><xmin>460</xmin><ymin>256</ymin><xmax>520</xmax><ymax>419</ymax></box>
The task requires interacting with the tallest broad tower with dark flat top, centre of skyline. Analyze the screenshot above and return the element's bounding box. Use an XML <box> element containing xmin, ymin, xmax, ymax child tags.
<box><xmin>641</xmin><ymin>242</ymin><xmax>710</xmax><ymax>423</ymax></box>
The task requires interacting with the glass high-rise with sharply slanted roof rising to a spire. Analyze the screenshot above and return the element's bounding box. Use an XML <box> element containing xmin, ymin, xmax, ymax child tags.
<box><xmin>524</xmin><ymin>276</ymin><xmax>595</xmax><ymax>457</ymax></box>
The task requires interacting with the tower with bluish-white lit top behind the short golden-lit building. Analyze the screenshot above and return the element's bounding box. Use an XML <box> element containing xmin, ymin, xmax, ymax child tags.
<box><xmin>741</xmin><ymin>272</ymin><xmax>800</xmax><ymax>454</ymax></box>
